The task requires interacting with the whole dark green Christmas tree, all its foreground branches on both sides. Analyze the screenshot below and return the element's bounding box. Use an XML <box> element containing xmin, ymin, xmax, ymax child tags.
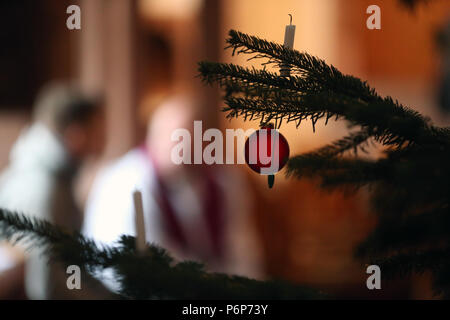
<box><xmin>0</xmin><ymin>1</ymin><xmax>450</xmax><ymax>299</ymax></box>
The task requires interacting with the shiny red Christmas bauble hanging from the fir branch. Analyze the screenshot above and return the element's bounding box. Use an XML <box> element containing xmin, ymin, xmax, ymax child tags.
<box><xmin>245</xmin><ymin>126</ymin><xmax>289</xmax><ymax>187</ymax></box>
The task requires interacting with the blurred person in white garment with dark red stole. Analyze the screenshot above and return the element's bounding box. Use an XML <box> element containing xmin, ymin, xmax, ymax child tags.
<box><xmin>83</xmin><ymin>97</ymin><xmax>261</xmax><ymax>290</ymax></box>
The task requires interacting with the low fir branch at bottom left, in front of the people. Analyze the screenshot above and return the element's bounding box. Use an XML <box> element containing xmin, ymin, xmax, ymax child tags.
<box><xmin>0</xmin><ymin>209</ymin><xmax>324</xmax><ymax>299</ymax></box>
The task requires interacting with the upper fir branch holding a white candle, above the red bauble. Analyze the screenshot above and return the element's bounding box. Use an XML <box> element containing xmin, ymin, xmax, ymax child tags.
<box><xmin>199</xmin><ymin>30</ymin><xmax>450</xmax><ymax>146</ymax></box>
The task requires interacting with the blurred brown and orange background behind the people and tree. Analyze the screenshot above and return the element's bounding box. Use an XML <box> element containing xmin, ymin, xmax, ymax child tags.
<box><xmin>0</xmin><ymin>0</ymin><xmax>450</xmax><ymax>298</ymax></box>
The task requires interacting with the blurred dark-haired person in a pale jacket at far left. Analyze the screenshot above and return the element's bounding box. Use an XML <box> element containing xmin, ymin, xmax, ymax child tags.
<box><xmin>0</xmin><ymin>83</ymin><xmax>108</xmax><ymax>299</ymax></box>
